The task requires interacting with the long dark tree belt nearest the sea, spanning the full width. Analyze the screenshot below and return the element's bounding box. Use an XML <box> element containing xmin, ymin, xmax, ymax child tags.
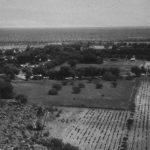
<box><xmin>0</xmin><ymin>42</ymin><xmax>150</xmax><ymax>66</ymax></box>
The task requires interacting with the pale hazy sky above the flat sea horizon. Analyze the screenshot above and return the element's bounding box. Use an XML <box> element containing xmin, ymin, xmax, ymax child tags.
<box><xmin>0</xmin><ymin>0</ymin><xmax>150</xmax><ymax>27</ymax></box>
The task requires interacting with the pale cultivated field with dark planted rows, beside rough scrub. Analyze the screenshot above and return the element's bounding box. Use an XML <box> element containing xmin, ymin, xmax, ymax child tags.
<box><xmin>46</xmin><ymin>80</ymin><xmax>150</xmax><ymax>150</ymax></box>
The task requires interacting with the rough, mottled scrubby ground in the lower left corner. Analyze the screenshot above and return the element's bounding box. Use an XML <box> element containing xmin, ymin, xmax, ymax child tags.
<box><xmin>0</xmin><ymin>99</ymin><xmax>78</xmax><ymax>150</ymax></box>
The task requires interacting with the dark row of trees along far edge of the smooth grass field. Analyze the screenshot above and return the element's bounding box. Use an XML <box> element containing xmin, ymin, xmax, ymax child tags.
<box><xmin>47</xmin><ymin>66</ymin><xmax>120</xmax><ymax>81</ymax></box>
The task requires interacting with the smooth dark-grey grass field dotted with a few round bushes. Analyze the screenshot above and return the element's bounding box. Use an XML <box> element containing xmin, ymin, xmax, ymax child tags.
<box><xmin>13</xmin><ymin>80</ymin><xmax>135</xmax><ymax>109</ymax></box>
